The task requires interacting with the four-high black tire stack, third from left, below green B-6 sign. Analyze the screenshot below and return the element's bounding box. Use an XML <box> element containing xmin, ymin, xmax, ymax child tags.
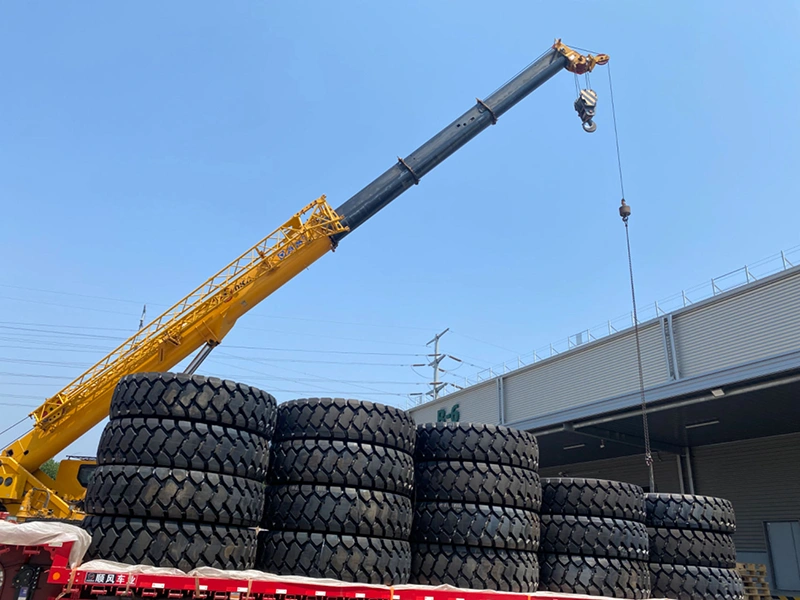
<box><xmin>411</xmin><ymin>423</ymin><xmax>541</xmax><ymax>593</ymax></box>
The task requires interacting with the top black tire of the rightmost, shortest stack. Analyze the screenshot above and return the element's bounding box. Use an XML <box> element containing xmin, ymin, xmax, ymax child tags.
<box><xmin>645</xmin><ymin>494</ymin><xmax>736</xmax><ymax>533</ymax></box>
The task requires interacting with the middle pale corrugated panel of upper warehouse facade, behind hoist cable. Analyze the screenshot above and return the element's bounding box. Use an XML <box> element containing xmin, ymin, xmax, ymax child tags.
<box><xmin>504</xmin><ymin>322</ymin><xmax>668</xmax><ymax>423</ymax></box>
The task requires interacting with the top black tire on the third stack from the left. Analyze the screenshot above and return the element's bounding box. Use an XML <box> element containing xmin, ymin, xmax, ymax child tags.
<box><xmin>414</xmin><ymin>423</ymin><xmax>539</xmax><ymax>471</ymax></box>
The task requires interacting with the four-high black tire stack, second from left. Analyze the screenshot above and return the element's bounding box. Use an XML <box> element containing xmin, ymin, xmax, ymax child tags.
<box><xmin>256</xmin><ymin>398</ymin><xmax>415</xmax><ymax>585</ymax></box>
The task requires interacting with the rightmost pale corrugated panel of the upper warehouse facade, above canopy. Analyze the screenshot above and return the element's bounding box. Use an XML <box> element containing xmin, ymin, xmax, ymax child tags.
<box><xmin>673</xmin><ymin>274</ymin><xmax>800</xmax><ymax>377</ymax></box>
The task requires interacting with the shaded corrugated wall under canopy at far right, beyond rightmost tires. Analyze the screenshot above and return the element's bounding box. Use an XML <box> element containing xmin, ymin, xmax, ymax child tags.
<box><xmin>692</xmin><ymin>433</ymin><xmax>800</xmax><ymax>551</ymax></box>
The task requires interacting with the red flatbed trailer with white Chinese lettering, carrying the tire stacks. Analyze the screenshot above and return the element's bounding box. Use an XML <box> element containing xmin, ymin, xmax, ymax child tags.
<box><xmin>0</xmin><ymin>530</ymin><xmax>656</xmax><ymax>600</ymax></box>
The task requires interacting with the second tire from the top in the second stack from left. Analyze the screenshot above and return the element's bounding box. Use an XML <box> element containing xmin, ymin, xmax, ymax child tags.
<box><xmin>270</xmin><ymin>440</ymin><xmax>414</xmax><ymax>497</ymax></box>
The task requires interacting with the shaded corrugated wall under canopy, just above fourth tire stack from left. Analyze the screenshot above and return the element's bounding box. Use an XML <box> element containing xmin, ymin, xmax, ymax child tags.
<box><xmin>539</xmin><ymin>453</ymin><xmax>681</xmax><ymax>494</ymax></box>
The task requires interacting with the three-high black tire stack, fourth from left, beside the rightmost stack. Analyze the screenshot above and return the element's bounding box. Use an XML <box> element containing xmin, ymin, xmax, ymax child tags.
<box><xmin>539</xmin><ymin>477</ymin><xmax>650</xmax><ymax>598</ymax></box>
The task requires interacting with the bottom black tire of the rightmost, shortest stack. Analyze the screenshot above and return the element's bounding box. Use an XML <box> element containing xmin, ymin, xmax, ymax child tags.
<box><xmin>650</xmin><ymin>563</ymin><xmax>745</xmax><ymax>600</ymax></box>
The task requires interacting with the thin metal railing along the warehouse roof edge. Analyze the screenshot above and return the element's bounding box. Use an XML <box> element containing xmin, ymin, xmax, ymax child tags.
<box><xmin>450</xmin><ymin>246</ymin><xmax>800</xmax><ymax>390</ymax></box>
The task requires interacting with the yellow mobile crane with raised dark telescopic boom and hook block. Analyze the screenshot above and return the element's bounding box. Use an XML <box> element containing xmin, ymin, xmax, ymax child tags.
<box><xmin>0</xmin><ymin>40</ymin><xmax>609</xmax><ymax>520</ymax></box>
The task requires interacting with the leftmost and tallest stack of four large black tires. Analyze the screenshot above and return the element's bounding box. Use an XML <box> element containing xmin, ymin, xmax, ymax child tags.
<box><xmin>82</xmin><ymin>373</ymin><xmax>276</xmax><ymax>571</ymax></box>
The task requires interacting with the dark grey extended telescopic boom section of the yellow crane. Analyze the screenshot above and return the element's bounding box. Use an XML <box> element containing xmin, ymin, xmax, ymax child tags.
<box><xmin>333</xmin><ymin>49</ymin><xmax>569</xmax><ymax>243</ymax></box>
